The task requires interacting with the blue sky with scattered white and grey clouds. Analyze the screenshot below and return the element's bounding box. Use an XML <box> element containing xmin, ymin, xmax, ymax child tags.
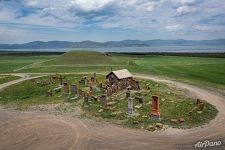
<box><xmin>0</xmin><ymin>0</ymin><xmax>225</xmax><ymax>43</ymax></box>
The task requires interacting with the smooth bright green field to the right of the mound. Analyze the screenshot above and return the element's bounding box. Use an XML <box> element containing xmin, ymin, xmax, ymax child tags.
<box><xmin>128</xmin><ymin>56</ymin><xmax>225</xmax><ymax>90</ymax></box>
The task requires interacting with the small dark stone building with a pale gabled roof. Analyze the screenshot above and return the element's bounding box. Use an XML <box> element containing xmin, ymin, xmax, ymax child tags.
<box><xmin>106</xmin><ymin>69</ymin><xmax>132</xmax><ymax>85</ymax></box>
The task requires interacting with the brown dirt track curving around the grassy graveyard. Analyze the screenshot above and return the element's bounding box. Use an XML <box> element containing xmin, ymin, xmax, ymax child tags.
<box><xmin>0</xmin><ymin>75</ymin><xmax>225</xmax><ymax>150</ymax></box>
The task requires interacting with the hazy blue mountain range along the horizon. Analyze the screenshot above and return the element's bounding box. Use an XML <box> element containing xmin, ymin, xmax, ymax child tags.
<box><xmin>0</xmin><ymin>39</ymin><xmax>225</xmax><ymax>49</ymax></box>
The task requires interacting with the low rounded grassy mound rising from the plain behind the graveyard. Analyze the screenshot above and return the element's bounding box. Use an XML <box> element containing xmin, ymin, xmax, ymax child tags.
<box><xmin>45</xmin><ymin>51</ymin><xmax>126</xmax><ymax>66</ymax></box>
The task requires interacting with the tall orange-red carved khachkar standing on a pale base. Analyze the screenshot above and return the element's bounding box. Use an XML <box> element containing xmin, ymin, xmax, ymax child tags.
<box><xmin>150</xmin><ymin>95</ymin><xmax>160</xmax><ymax>120</ymax></box>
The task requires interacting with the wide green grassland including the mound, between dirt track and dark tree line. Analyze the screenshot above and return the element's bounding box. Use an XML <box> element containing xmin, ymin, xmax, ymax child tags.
<box><xmin>0</xmin><ymin>51</ymin><xmax>225</xmax><ymax>93</ymax></box>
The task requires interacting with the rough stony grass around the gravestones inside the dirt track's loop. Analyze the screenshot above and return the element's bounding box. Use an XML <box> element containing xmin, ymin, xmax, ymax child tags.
<box><xmin>0</xmin><ymin>74</ymin><xmax>217</xmax><ymax>128</ymax></box>
